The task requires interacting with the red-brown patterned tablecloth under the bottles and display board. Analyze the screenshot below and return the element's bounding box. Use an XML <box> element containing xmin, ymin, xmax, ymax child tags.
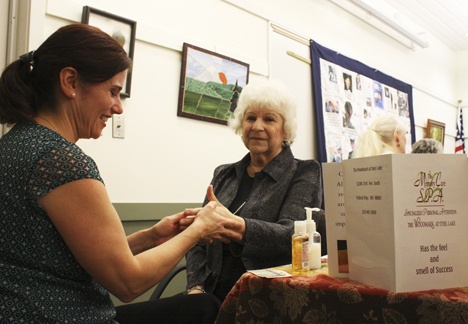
<box><xmin>216</xmin><ymin>264</ymin><xmax>468</xmax><ymax>324</ymax></box>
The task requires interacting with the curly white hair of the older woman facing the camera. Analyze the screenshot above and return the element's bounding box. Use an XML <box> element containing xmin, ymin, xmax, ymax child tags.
<box><xmin>228</xmin><ymin>79</ymin><xmax>297</xmax><ymax>145</ymax></box>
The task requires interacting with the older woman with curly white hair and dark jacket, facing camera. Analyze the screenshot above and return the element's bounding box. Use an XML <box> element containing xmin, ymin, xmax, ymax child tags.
<box><xmin>187</xmin><ymin>81</ymin><xmax>325</xmax><ymax>300</ymax></box>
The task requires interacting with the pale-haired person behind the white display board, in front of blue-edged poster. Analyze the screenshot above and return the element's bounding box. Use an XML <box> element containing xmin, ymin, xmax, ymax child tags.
<box><xmin>353</xmin><ymin>114</ymin><xmax>406</xmax><ymax>158</ymax></box>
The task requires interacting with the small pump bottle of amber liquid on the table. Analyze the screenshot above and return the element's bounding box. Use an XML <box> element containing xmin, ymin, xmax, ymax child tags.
<box><xmin>292</xmin><ymin>221</ymin><xmax>309</xmax><ymax>274</ymax></box>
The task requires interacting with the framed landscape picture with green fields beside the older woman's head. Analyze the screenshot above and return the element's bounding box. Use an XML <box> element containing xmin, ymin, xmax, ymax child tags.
<box><xmin>177</xmin><ymin>43</ymin><xmax>249</xmax><ymax>125</ymax></box>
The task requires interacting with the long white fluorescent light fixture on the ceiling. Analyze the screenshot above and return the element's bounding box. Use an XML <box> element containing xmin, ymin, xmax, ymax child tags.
<box><xmin>331</xmin><ymin>0</ymin><xmax>429</xmax><ymax>50</ymax></box>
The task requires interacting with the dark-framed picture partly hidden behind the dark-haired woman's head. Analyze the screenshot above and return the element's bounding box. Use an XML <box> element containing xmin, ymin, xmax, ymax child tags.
<box><xmin>81</xmin><ymin>6</ymin><xmax>136</xmax><ymax>98</ymax></box>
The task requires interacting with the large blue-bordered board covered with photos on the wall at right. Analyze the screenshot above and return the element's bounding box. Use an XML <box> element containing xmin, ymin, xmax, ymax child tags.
<box><xmin>310</xmin><ymin>41</ymin><xmax>415</xmax><ymax>162</ymax></box>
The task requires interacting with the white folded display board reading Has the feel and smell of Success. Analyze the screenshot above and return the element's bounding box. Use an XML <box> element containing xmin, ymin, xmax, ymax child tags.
<box><xmin>340</xmin><ymin>154</ymin><xmax>468</xmax><ymax>292</ymax></box>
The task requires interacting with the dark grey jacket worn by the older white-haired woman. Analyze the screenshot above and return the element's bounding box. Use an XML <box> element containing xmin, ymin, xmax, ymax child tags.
<box><xmin>186</xmin><ymin>147</ymin><xmax>322</xmax><ymax>292</ymax></box>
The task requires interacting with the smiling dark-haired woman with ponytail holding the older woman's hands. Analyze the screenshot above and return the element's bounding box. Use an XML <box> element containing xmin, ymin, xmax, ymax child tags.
<box><xmin>0</xmin><ymin>24</ymin><xmax>239</xmax><ymax>323</ymax></box>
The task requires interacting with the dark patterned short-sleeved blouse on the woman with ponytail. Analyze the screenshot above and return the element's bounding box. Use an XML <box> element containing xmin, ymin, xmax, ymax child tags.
<box><xmin>0</xmin><ymin>123</ymin><xmax>115</xmax><ymax>323</ymax></box>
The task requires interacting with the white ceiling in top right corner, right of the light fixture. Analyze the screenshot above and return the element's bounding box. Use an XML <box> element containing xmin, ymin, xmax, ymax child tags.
<box><xmin>386</xmin><ymin>0</ymin><xmax>468</xmax><ymax>51</ymax></box>
